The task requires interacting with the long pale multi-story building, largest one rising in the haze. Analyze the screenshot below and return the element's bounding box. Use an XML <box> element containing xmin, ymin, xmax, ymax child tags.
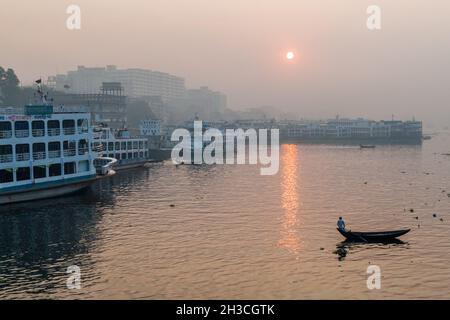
<box><xmin>48</xmin><ymin>65</ymin><xmax>185</xmax><ymax>102</ymax></box>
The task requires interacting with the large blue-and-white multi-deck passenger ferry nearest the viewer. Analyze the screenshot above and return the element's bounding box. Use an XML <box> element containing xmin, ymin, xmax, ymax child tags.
<box><xmin>0</xmin><ymin>91</ymin><xmax>114</xmax><ymax>204</ymax></box>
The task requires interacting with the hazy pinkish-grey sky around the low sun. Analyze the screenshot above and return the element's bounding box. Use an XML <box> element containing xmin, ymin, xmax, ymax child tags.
<box><xmin>0</xmin><ymin>0</ymin><xmax>450</xmax><ymax>125</ymax></box>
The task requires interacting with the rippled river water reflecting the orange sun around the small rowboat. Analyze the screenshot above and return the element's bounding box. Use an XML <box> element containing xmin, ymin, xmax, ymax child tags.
<box><xmin>0</xmin><ymin>134</ymin><xmax>450</xmax><ymax>299</ymax></box>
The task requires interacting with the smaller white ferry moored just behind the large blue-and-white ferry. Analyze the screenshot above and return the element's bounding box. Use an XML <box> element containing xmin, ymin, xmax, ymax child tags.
<box><xmin>94</xmin><ymin>126</ymin><xmax>151</xmax><ymax>170</ymax></box>
